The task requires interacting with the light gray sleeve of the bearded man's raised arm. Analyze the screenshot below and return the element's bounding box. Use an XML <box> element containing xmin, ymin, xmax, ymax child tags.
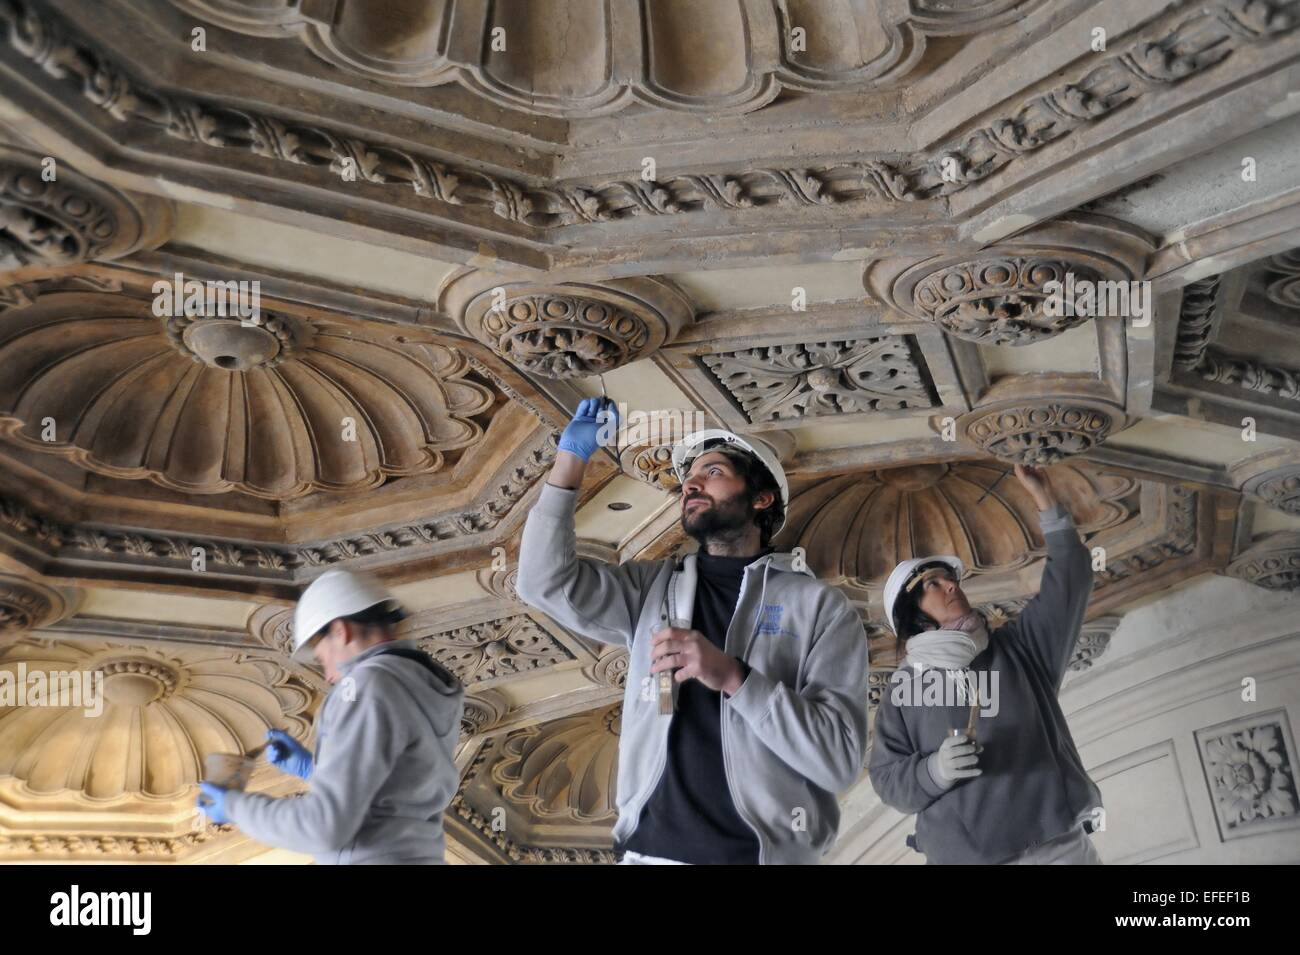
<box><xmin>515</xmin><ymin>485</ymin><xmax>659</xmax><ymax>646</ymax></box>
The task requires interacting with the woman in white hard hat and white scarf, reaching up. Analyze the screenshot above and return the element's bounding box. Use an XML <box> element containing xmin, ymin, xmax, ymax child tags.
<box><xmin>870</xmin><ymin>465</ymin><xmax>1104</xmax><ymax>865</ymax></box>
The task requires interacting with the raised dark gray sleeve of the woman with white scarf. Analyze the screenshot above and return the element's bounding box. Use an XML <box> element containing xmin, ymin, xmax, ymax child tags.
<box><xmin>1010</xmin><ymin>504</ymin><xmax>1092</xmax><ymax>690</ymax></box>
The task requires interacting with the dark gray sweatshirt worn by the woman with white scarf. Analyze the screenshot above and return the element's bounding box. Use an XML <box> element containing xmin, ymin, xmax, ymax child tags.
<box><xmin>871</xmin><ymin>504</ymin><xmax>1101</xmax><ymax>864</ymax></box>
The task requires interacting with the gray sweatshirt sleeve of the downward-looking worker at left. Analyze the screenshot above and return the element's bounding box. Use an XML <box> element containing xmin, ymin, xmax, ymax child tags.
<box><xmin>226</xmin><ymin>670</ymin><xmax>410</xmax><ymax>855</ymax></box>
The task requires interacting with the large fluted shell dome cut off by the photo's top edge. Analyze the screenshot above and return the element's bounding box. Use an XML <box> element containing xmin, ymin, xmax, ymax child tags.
<box><xmin>172</xmin><ymin>0</ymin><xmax>1041</xmax><ymax>117</ymax></box>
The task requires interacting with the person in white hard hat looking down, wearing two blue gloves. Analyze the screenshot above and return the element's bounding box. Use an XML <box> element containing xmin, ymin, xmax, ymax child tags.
<box><xmin>199</xmin><ymin>570</ymin><xmax>464</xmax><ymax>865</ymax></box>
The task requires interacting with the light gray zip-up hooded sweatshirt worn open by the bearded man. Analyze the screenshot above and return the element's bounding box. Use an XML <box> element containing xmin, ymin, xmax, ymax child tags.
<box><xmin>516</xmin><ymin>485</ymin><xmax>867</xmax><ymax>864</ymax></box>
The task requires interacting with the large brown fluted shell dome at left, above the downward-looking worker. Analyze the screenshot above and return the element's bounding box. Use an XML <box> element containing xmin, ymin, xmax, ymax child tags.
<box><xmin>0</xmin><ymin>294</ymin><xmax>494</xmax><ymax>500</ymax></box>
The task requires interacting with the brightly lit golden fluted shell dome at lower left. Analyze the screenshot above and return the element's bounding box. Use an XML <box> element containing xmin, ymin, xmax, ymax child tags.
<box><xmin>0</xmin><ymin>638</ymin><xmax>319</xmax><ymax>804</ymax></box>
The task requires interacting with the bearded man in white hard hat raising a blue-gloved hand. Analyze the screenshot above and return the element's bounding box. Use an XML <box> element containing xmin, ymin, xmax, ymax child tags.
<box><xmin>516</xmin><ymin>399</ymin><xmax>867</xmax><ymax>864</ymax></box>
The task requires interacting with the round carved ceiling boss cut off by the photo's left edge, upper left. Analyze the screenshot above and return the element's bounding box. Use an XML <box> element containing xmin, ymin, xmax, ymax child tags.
<box><xmin>0</xmin><ymin>146</ymin><xmax>173</xmax><ymax>273</ymax></box>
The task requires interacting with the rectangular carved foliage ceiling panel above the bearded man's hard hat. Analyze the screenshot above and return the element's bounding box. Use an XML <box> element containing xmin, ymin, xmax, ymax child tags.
<box><xmin>701</xmin><ymin>335</ymin><xmax>936</xmax><ymax>424</ymax></box>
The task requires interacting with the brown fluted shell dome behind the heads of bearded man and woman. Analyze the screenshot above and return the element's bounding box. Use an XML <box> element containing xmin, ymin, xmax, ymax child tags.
<box><xmin>775</xmin><ymin>463</ymin><xmax>1135</xmax><ymax>589</ymax></box>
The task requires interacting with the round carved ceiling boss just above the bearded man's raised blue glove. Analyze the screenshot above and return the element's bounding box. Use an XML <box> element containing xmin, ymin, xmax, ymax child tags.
<box><xmin>439</xmin><ymin>272</ymin><xmax>693</xmax><ymax>378</ymax></box>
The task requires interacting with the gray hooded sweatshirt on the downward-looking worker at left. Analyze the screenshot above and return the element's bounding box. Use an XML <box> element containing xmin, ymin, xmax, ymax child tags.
<box><xmin>226</xmin><ymin>641</ymin><xmax>464</xmax><ymax>865</ymax></box>
